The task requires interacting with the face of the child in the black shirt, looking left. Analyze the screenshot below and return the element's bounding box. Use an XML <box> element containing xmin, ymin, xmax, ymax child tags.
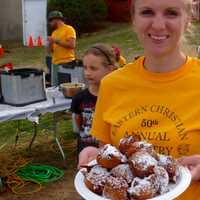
<box><xmin>83</xmin><ymin>54</ymin><xmax>113</xmax><ymax>85</ymax></box>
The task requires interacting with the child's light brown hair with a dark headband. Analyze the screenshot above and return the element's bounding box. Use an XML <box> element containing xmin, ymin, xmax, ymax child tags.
<box><xmin>84</xmin><ymin>43</ymin><xmax>117</xmax><ymax>67</ymax></box>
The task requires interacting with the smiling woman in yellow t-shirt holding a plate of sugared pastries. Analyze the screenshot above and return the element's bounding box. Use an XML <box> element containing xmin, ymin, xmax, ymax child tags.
<box><xmin>79</xmin><ymin>0</ymin><xmax>200</xmax><ymax>200</ymax></box>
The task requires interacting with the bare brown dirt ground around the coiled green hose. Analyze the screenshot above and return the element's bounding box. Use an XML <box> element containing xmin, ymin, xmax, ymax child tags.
<box><xmin>0</xmin><ymin>138</ymin><xmax>80</xmax><ymax>200</ymax></box>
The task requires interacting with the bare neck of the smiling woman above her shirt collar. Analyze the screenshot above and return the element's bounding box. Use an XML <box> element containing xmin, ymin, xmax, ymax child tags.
<box><xmin>144</xmin><ymin>52</ymin><xmax>186</xmax><ymax>73</ymax></box>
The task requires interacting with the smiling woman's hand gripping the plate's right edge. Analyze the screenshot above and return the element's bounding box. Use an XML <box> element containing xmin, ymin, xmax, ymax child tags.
<box><xmin>179</xmin><ymin>155</ymin><xmax>200</xmax><ymax>181</ymax></box>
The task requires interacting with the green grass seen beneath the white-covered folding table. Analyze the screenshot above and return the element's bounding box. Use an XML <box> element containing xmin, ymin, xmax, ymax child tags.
<box><xmin>0</xmin><ymin>114</ymin><xmax>75</xmax><ymax>148</ymax></box>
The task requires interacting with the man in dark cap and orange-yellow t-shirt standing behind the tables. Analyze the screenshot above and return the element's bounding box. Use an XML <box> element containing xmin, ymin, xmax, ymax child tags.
<box><xmin>48</xmin><ymin>11</ymin><xmax>82</xmax><ymax>86</ymax></box>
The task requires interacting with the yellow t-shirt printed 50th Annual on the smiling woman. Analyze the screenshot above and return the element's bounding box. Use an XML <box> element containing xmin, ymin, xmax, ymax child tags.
<box><xmin>91</xmin><ymin>57</ymin><xmax>200</xmax><ymax>200</ymax></box>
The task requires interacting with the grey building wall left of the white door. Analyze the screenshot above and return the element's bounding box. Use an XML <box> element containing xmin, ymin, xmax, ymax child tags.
<box><xmin>0</xmin><ymin>0</ymin><xmax>23</xmax><ymax>41</ymax></box>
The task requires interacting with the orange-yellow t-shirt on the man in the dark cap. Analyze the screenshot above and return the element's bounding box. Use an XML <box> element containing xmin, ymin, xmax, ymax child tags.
<box><xmin>52</xmin><ymin>24</ymin><xmax>76</xmax><ymax>64</ymax></box>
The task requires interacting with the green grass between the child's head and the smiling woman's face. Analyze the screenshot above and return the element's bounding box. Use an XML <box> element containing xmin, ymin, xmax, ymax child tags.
<box><xmin>77</xmin><ymin>24</ymin><xmax>142</xmax><ymax>61</ymax></box>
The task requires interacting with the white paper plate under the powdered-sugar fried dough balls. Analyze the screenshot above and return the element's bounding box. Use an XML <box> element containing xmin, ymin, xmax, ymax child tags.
<box><xmin>74</xmin><ymin>161</ymin><xmax>191</xmax><ymax>200</ymax></box>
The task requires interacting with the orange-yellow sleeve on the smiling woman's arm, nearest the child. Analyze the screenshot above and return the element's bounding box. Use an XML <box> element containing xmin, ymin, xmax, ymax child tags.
<box><xmin>90</xmin><ymin>81</ymin><xmax>111</xmax><ymax>144</ymax></box>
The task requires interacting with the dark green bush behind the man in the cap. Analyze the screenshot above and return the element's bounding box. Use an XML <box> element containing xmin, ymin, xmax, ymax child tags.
<box><xmin>48</xmin><ymin>0</ymin><xmax>107</xmax><ymax>33</ymax></box>
